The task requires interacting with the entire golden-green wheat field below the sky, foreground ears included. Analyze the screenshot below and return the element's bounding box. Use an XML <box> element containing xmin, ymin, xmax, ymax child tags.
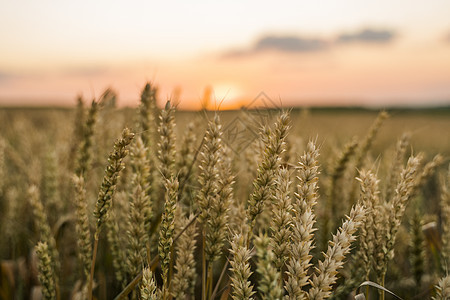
<box><xmin>0</xmin><ymin>84</ymin><xmax>450</xmax><ymax>300</ymax></box>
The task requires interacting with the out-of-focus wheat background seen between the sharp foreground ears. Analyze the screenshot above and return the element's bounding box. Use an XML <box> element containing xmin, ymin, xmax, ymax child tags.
<box><xmin>0</xmin><ymin>103</ymin><xmax>450</xmax><ymax>299</ymax></box>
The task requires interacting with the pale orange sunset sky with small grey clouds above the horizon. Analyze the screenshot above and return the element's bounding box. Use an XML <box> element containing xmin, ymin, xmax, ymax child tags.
<box><xmin>0</xmin><ymin>0</ymin><xmax>450</xmax><ymax>109</ymax></box>
